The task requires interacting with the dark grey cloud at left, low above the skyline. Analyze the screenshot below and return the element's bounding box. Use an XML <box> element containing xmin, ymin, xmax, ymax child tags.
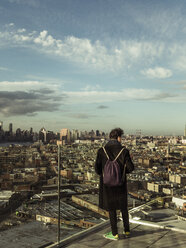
<box><xmin>0</xmin><ymin>88</ymin><xmax>65</xmax><ymax>117</ymax></box>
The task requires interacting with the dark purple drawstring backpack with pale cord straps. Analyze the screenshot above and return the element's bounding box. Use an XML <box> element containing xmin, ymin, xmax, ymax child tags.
<box><xmin>103</xmin><ymin>147</ymin><xmax>125</xmax><ymax>187</ymax></box>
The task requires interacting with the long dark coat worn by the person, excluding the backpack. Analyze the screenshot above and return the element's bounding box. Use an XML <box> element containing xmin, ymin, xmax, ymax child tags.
<box><xmin>95</xmin><ymin>140</ymin><xmax>134</xmax><ymax>211</ymax></box>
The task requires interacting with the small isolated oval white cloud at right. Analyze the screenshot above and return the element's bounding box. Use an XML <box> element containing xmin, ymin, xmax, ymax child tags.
<box><xmin>141</xmin><ymin>67</ymin><xmax>172</xmax><ymax>78</ymax></box>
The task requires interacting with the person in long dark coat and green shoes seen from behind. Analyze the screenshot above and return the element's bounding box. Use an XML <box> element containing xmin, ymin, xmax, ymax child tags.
<box><xmin>95</xmin><ymin>128</ymin><xmax>134</xmax><ymax>240</ymax></box>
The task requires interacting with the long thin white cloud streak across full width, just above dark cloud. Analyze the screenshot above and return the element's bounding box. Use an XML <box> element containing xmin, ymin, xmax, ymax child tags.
<box><xmin>0</xmin><ymin>78</ymin><xmax>186</xmax><ymax>106</ymax></box>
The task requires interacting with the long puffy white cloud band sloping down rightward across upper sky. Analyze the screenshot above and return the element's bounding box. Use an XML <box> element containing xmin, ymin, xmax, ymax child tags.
<box><xmin>0</xmin><ymin>28</ymin><xmax>166</xmax><ymax>71</ymax></box>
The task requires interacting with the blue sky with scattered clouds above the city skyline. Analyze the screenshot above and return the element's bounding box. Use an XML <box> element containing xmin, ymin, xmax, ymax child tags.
<box><xmin>0</xmin><ymin>0</ymin><xmax>186</xmax><ymax>135</ymax></box>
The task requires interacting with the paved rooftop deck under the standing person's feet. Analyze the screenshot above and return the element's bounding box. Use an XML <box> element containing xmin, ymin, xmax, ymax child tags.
<box><xmin>48</xmin><ymin>221</ymin><xmax>186</xmax><ymax>248</ymax></box>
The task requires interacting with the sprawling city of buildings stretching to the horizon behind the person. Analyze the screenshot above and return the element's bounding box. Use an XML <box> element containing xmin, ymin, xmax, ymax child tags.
<box><xmin>0</xmin><ymin>122</ymin><xmax>186</xmax><ymax>242</ymax></box>
